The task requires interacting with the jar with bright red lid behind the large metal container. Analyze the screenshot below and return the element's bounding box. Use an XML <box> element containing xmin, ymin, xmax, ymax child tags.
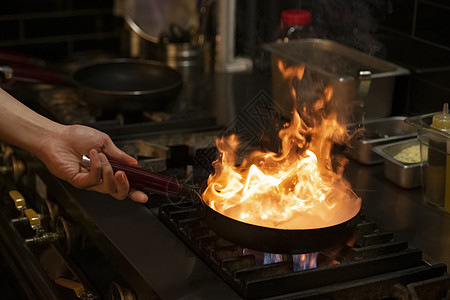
<box><xmin>280</xmin><ymin>9</ymin><xmax>314</xmax><ymax>43</ymax></box>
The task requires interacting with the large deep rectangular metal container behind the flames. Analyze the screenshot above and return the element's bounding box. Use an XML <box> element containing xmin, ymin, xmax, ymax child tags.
<box><xmin>264</xmin><ymin>39</ymin><xmax>409</xmax><ymax>124</ymax></box>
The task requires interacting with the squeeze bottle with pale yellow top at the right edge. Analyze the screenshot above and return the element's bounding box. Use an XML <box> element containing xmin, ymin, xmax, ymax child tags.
<box><xmin>428</xmin><ymin>103</ymin><xmax>450</xmax><ymax>213</ymax></box>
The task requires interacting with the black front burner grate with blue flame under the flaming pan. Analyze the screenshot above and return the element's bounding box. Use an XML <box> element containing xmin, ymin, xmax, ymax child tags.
<box><xmin>159</xmin><ymin>202</ymin><xmax>448</xmax><ymax>300</ymax></box>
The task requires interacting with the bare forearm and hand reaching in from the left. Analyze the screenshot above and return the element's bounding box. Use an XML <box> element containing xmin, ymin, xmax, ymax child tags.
<box><xmin>0</xmin><ymin>89</ymin><xmax>148</xmax><ymax>202</ymax></box>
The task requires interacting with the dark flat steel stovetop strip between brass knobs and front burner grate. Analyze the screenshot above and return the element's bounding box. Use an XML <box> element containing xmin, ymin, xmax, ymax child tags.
<box><xmin>66</xmin><ymin>185</ymin><xmax>240</xmax><ymax>299</ymax></box>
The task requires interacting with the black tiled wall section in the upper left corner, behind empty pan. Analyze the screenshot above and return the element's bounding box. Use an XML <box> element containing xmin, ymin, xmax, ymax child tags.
<box><xmin>0</xmin><ymin>0</ymin><xmax>123</xmax><ymax>60</ymax></box>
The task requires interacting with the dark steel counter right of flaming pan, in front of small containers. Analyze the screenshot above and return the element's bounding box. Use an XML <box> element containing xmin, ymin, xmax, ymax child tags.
<box><xmin>347</xmin><ymin>161</ymin><xmax>450</xmax><ymax>266</ymax></box>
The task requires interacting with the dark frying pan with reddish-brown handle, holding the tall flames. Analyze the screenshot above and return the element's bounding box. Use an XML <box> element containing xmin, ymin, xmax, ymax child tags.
<box><xmin>101</xmin><ymin>161</ymin><xmax>360</xmax><ymax>254</ymax></box>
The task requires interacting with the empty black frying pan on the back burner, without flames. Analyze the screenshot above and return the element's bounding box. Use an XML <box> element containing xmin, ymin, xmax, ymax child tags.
<box><xmin>0</xmin><ymin>51</ymin><xmax>182</xmax><ymax>112</ymax></box>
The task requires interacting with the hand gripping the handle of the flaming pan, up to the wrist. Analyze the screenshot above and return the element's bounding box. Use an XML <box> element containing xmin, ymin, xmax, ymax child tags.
<box><xmin>37</xmin><ymin>125</ymin><xmax>148</xmax><ymax>203</ymax></box>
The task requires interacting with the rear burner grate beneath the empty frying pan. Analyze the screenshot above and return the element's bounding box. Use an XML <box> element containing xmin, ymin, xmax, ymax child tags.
<box><xmin>39</xmin><ymin>87</ymin><xmax>217</xmax><ymax>140</ymax></box>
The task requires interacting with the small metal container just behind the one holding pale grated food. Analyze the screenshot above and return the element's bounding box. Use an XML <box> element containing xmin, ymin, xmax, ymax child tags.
<box><xmin>347</xmin><ymin>116</ymin><xmax>417</xmax><ymax>165</ymax></box>
